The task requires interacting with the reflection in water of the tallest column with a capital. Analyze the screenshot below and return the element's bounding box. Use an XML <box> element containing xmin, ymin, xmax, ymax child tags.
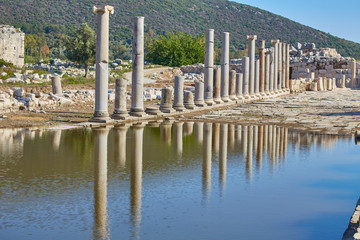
<box><xmin>93</xmin><ymin>128</ymin><xmax>109</xmax><ymax>239</ymax></box>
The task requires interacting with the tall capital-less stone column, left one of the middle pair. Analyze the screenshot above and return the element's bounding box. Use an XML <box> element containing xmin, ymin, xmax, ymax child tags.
<box><xmin>204</xmin><ymin>29</ymin><xmax>214</xmax><ymax>106</ymax></box>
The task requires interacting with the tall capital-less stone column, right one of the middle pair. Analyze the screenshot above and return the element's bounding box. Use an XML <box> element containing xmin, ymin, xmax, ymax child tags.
<box><xmin>221</xmin><ymin>32</ymin><xmax>230</xmax><ymax>102</ymax></box>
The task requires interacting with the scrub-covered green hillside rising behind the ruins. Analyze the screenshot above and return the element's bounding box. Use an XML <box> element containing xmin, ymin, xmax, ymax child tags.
<box><xmin>0</xmin><ymin>0</ymin><xmax>360</xmax><ymax>59</ymax></box>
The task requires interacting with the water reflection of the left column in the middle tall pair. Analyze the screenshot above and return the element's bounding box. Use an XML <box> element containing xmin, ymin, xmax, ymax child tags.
<box><xmin>202</xmin><ymin>123</ymin><xmax>212</xmax><ymax>199</ymax></box>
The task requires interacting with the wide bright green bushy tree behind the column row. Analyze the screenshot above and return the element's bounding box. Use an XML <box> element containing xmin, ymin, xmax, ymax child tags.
<box><xmin>146</xmin><ymin>32</ymin><xmax>205</xmax><ymax>67</ymax></box>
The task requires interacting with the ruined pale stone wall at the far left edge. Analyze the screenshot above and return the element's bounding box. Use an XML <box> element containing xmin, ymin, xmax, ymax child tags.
<box><xmin>0</xmin><ymin>25</ymin><xmax>25</xmax><ymax>67</ymax></box>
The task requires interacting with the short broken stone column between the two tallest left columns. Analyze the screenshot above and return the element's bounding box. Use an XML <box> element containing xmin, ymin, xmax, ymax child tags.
<box><xmin>111</xmin><ymin>78</ymin><xmax>129</xmax><ymax>119</ymax></box>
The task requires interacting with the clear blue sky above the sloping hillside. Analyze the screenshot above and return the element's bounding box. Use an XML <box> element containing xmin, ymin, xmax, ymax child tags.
<box><xmin>233</xmin><ymin>0</ymin><xmax>360</xmax><ymax>43</ymax></box>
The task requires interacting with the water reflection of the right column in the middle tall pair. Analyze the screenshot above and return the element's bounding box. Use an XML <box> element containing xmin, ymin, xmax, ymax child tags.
<box><xmin>219</xmin><ymin>123</ymin><xmax>228</xmax><ymax>193</ymax></box>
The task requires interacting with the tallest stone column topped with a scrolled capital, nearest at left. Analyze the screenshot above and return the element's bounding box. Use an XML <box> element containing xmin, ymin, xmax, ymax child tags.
<box><xmin>90</xmin><ymin>6</ymin><xmax>114</xmax><ymax>122</ymax></box>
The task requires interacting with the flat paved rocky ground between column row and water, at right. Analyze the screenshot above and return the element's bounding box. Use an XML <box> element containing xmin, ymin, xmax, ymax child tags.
<box><xmin>195</xmin><ymin>89</ymin><xmax>360</xmax><ymax>134</ymax></box>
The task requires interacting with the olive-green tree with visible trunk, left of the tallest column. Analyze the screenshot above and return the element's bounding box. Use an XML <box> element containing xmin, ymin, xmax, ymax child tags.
<box><xmin>65</xmin><ymin>23</ymin><xmax>96</xmax><ymax>78</ymax></box>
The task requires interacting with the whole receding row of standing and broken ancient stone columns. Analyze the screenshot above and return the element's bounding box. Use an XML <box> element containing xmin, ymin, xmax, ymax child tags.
<box><xmin>90</xmin><ymin>6</ymin><xmax>289</xmax><ymax>122</ymax></box>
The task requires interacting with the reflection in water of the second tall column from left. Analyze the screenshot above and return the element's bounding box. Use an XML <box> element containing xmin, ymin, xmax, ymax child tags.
<box><xmin>130</xmin><ymin>124</ymin><xmax>144</xmax><ymax>238</ymax></box>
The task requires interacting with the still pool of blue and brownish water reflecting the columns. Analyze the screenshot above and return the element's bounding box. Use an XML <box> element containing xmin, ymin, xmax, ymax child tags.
<box><xmin>0</xmin><ymin>122</ymin><xmax>360</xmax><ymax>240</ymax></box>
